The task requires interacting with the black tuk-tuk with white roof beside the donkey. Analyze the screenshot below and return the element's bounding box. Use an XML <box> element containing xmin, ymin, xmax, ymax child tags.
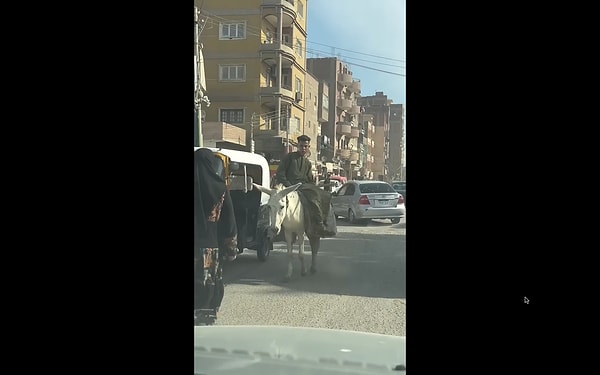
<box><xmin>194</xmin><ymin>147</ymin><xmax>273</xmax><ymax>262</ymax></box>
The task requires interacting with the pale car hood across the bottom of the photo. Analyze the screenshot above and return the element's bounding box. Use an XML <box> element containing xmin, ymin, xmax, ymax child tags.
<box><xmin>194</xmin><ymin>326</ymin><xmax>406</xmax><ymax>375</ymax></box>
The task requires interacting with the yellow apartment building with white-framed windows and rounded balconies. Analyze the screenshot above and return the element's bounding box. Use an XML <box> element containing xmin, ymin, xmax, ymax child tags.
<box><xmin>199</xmin><ymin>0</ymin><xmax>316</xmax><ymax>163</ymax></box>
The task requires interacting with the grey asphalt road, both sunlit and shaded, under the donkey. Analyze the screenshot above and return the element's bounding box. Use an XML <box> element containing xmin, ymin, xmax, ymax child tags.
<box><xmin>216</xmin><ymin>214</ymin><xmax>406</xmax><ymax>336</ymax></box>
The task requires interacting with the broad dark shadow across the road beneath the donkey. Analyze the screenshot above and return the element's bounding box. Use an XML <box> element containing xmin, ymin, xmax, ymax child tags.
<box><xmin>223</xmin><ymin>231</ymin><xmax>406</xmax><ymax>298</ymax></box>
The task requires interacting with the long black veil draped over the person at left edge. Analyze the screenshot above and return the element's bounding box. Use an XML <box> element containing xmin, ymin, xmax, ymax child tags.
<box><xmin>194</xmin><ymin>148</ymin><xmax>237</xmax><ymax>248</ymax></box>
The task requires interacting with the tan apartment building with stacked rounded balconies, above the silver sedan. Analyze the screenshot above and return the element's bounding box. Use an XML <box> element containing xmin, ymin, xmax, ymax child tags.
<box><xmin>306</xmin><ymin>57</ymin><xmax>360</xmax><ymax>176</ymax></box>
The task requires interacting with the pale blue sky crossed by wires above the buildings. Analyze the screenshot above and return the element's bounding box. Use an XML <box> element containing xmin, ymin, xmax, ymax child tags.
<box><xmin>305</xmin><ymin>0</ymin><xmax>406</xmax><ymax>105</ymax></box>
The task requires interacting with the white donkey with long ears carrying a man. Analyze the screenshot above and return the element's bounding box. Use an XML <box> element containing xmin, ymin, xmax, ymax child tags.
<box><xmin>253</xmin><ymin>183</ymin><xmax>321</xmax><ymax>281</ymax></box>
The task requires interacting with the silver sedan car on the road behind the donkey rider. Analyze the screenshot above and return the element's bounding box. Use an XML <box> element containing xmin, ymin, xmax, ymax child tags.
<box><xmin>331</xmin><ymin>180</ymin><xmax>405</xmax><ymax>224</ymax></box>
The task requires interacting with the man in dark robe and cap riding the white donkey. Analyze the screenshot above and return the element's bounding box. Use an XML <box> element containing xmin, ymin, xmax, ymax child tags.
<box><xmin>276</xmin><ymin>135</ymin><xmax>336</xmax><ymax>237</ymax></box>
